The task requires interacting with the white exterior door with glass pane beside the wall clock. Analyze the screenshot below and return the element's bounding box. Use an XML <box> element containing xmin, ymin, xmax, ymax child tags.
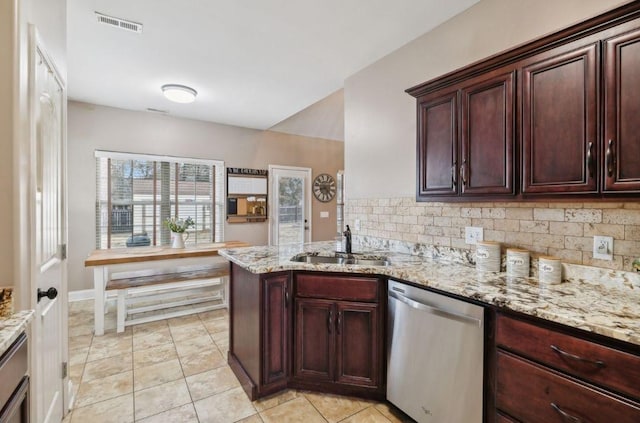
<box><xmin>269</xmin><ymin>165</ymin><xmax>311</xmax><ymax>245</ymax></box>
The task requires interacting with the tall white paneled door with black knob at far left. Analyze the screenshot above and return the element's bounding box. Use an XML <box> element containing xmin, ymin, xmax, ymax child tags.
<box><xmin>30</xmin><ymin>29</ymin><xmax>66</xmax><ymax>422</ymax></box>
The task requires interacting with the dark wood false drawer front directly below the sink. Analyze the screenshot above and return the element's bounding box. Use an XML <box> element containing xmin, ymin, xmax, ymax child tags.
<box><xmin>296</xmin><ymin>274</ymin><xmax>379</xmax><ymax>302</ymax></box>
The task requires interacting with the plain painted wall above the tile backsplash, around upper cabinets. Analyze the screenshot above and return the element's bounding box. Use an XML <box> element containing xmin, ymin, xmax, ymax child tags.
<box><xmin>344</xmin><ymin>0</ymin><xmax>626</xmax><ymax>198</ymax></box>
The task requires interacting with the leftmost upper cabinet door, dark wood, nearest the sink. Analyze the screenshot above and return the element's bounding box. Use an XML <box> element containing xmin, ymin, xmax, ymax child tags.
<box><xmin>416</xmin><ymin>91</ymin><xmax>458</xmax><ymax>199</ymax></box>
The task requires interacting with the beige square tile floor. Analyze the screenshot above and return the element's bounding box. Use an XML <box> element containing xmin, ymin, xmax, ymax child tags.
<box><xmin>65</xmin><ymin>300</ymin><xmax>410</xmax><ymax>423</ymax></box>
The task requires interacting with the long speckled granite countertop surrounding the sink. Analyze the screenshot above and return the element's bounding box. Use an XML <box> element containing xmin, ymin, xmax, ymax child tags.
<box><xmin>220</xmin><ymin>242</ymin><xmax>640</xmax><ymax>345</ymax></box>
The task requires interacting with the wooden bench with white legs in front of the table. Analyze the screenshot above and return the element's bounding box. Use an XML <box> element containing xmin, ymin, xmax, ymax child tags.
<box><xmin>105</xmin><ymin>261</ymin><xmax>229</xmax><ymax>333</ymax></box>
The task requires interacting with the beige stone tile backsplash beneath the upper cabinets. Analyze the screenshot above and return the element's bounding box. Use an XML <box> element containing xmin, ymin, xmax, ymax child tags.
<box><xmin>345</xmin><ymin>197</ymin><xmax>640</xmax><ymax>271</ymax></box>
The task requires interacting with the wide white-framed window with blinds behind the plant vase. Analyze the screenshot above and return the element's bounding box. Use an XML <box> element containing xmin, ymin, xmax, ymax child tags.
<box><xmin>95</xmin><ymin>151</ymin><xmax>224</xmax><ymax>249</ymax></box>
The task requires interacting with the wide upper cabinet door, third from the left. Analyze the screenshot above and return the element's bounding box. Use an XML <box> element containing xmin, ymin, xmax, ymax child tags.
<box><xmin>521</xmin><ymin>43</ymin><xmax>598</xmax><ymax>194</ymax></box>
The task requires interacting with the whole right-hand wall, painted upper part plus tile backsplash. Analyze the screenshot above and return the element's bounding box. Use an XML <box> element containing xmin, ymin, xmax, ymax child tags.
<box><xmin>344</xmin><ymin>0</ymin><xmax>640</xmax><ymax>270</ymax></box>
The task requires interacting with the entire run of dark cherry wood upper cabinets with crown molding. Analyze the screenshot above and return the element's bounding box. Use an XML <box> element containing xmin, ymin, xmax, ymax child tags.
<box><xmin>407</xmin><ymin>1</ymin><xmax>640</xmax><ymax>201</ymax></box>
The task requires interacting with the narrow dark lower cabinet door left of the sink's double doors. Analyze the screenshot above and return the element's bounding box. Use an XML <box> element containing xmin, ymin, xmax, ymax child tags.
<box><xmin>262</xmin><ymin>275</ymin><xmax>290</xmax><ymax>385</ymax></box>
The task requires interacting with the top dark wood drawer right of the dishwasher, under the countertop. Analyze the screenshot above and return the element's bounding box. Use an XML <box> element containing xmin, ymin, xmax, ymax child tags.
<box><xmin>496</xmin><ymin>315</ymin><xmax>640</xmax><ymax>399</ymax></box>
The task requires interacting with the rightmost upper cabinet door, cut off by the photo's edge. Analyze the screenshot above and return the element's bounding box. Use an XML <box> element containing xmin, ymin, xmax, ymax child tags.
<box><xmin>603</xmin><ymin>30</ymin><xmax>640</xmax><ymax>191</ymax></box>
